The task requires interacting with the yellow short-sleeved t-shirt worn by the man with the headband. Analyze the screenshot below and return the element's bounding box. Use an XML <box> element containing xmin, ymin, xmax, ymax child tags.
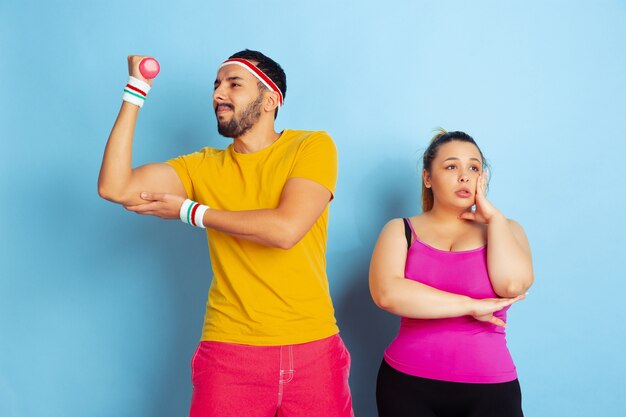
<box><xmin>168</xmin><ymin>130</ymin><xmax>339</xmax><ymax>346</ymax></box>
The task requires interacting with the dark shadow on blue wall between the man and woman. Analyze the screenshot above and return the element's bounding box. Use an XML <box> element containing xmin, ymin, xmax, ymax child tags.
<box><xmin>328</xmin><ymin>158</ymin><xmax>419</xmax><ymax>417</ymax></box>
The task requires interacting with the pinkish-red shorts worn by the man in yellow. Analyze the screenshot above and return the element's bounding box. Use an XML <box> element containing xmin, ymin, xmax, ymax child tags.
<box><xmin>190</xmin><ymin>334</ymin><xmax>354</xmax><ymax>417</ymax></box>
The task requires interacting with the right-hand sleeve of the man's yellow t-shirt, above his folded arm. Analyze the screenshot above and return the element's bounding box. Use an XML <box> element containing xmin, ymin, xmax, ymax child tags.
<box><xmin>289</xmin><ymin>132</ymin><xmax>338</xmax><ymax>196</ymax></box>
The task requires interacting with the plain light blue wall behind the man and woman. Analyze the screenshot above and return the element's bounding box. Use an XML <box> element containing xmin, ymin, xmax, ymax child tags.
<box><xmin>0</xmin><ymin>0</ymin><xmax>626</xmax><ymax>417</ymax></box>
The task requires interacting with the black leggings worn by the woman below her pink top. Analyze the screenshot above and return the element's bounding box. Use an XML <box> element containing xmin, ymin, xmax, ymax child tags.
<box><xmin>376</xmin><ymin>360</ymin><xmax>524</xmax><ymax>417</ymax></box>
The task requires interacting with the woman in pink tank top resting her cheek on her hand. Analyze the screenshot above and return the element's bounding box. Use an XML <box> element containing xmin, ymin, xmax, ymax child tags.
<box><xmin>370</xmin><ymin>131</ymin><xmax>533</xmax><ymax>417</ymax></box>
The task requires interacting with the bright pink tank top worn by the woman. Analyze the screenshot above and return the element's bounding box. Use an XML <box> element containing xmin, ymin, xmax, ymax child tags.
<box><xmin>385</xmin><ymin>222</ymin><xmax>517</xmax><ymax>383</ymax></box>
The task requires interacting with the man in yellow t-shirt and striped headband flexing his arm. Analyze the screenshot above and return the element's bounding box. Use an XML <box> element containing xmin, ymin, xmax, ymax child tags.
<box><xmin>98</xmin><ymin>50</ymin><xmax>353</xmax><ymax>417</ymax></box>
